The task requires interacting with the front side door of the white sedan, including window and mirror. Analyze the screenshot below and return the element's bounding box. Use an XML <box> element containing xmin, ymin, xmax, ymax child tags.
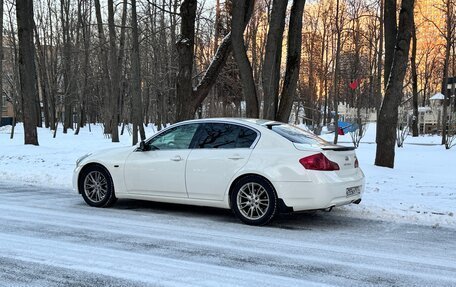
<box><xmin>124</xmin><ymin>124</ymin><xmax>199</xmax><ymax>198</ymax></box>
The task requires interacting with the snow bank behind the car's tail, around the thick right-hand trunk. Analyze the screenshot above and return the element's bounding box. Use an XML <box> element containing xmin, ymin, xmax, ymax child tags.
<box><xmin>322</xmin><ymin>124</ymin><xmax>456</xmax><ymax>226</ymax></box>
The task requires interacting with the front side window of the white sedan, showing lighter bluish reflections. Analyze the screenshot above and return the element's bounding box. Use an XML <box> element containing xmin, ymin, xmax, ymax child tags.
<box><xmin>147</xmin><ymin>124</ymin><xmax>198</xmax><ymax>150</ymax></box>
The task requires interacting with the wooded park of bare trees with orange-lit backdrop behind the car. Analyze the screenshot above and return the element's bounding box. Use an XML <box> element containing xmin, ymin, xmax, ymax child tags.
<box><xmin>0</xmin><ymin>0</ymin><xmax>456</xmax><ymax>167</ymax></box>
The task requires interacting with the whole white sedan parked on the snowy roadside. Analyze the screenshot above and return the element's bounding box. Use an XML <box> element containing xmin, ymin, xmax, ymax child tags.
<box><xmin>73</xmin><ymin>118</ymin><xmax>364</xmax><ymax>225</ymax></box>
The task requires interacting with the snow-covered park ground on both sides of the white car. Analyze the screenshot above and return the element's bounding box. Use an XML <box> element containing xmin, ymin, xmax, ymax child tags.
<box><xmin>0</xmin><ymin>124</ymin><xmax>456</xmax><ymax>227</ymax></box>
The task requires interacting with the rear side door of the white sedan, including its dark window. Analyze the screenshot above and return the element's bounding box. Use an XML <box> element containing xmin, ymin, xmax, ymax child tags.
<box><xmin>186</xmin><ymin>123</ymin><xmax>259</xmax><ymax>200</ymax></box>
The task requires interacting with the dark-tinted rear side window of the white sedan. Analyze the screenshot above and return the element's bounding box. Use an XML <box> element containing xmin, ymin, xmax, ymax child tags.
<box><xmin>195</xmin><ymin>123</ymin><xmax>257</xmax><ymax>148</ymax></box>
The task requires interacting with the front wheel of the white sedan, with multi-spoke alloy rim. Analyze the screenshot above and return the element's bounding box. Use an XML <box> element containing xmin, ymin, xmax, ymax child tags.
<box><xmin>78</xmin><ymin>165</ymin><xmax>117</xmax><ymax>207</ymax></box>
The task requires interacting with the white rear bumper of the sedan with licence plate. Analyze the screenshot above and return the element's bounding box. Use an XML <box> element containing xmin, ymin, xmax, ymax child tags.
<box><xmin>273</xmin><ymin>172</ymin><xmax>365</xmax><ymax>211</ymax></box>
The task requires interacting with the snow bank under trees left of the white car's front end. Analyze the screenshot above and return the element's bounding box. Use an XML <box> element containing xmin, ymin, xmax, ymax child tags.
<box><xmin>0</xmin><ymin>124</ymin><xmax>156</xmax><ymax>188</ymax></box>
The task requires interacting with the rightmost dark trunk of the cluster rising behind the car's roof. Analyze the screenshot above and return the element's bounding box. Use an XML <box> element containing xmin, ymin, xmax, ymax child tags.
<box><xmin>275</xmin><ymin>0</ymin><xmax>306</xmax><ymax>124</ymax></box>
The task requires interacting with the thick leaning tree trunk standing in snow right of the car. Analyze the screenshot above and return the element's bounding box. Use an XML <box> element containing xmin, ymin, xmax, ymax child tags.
<box><xmin>375</xmin><ymin>0</ymin><xmax>415</xmax><ymax>168</ymax></box>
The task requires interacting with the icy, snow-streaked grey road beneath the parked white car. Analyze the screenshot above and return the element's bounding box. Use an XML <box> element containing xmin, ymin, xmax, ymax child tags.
<box><xmin>0</xmin><ymin>181</ymin><xmax>456</xmax><ymax>287</ymax></box>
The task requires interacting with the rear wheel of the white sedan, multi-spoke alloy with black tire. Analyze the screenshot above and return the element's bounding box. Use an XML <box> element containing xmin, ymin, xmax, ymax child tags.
<box><xmin>230</xmin><ymin>175</ymin><xmax>277</xmax><ymax>225</ymax></box>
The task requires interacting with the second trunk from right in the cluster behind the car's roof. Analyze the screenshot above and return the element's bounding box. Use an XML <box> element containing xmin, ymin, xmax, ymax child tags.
<box><xmin>261</xmin><ymin>0</ymin><xmax>286</xmax><ymax>120</ymax></box>
